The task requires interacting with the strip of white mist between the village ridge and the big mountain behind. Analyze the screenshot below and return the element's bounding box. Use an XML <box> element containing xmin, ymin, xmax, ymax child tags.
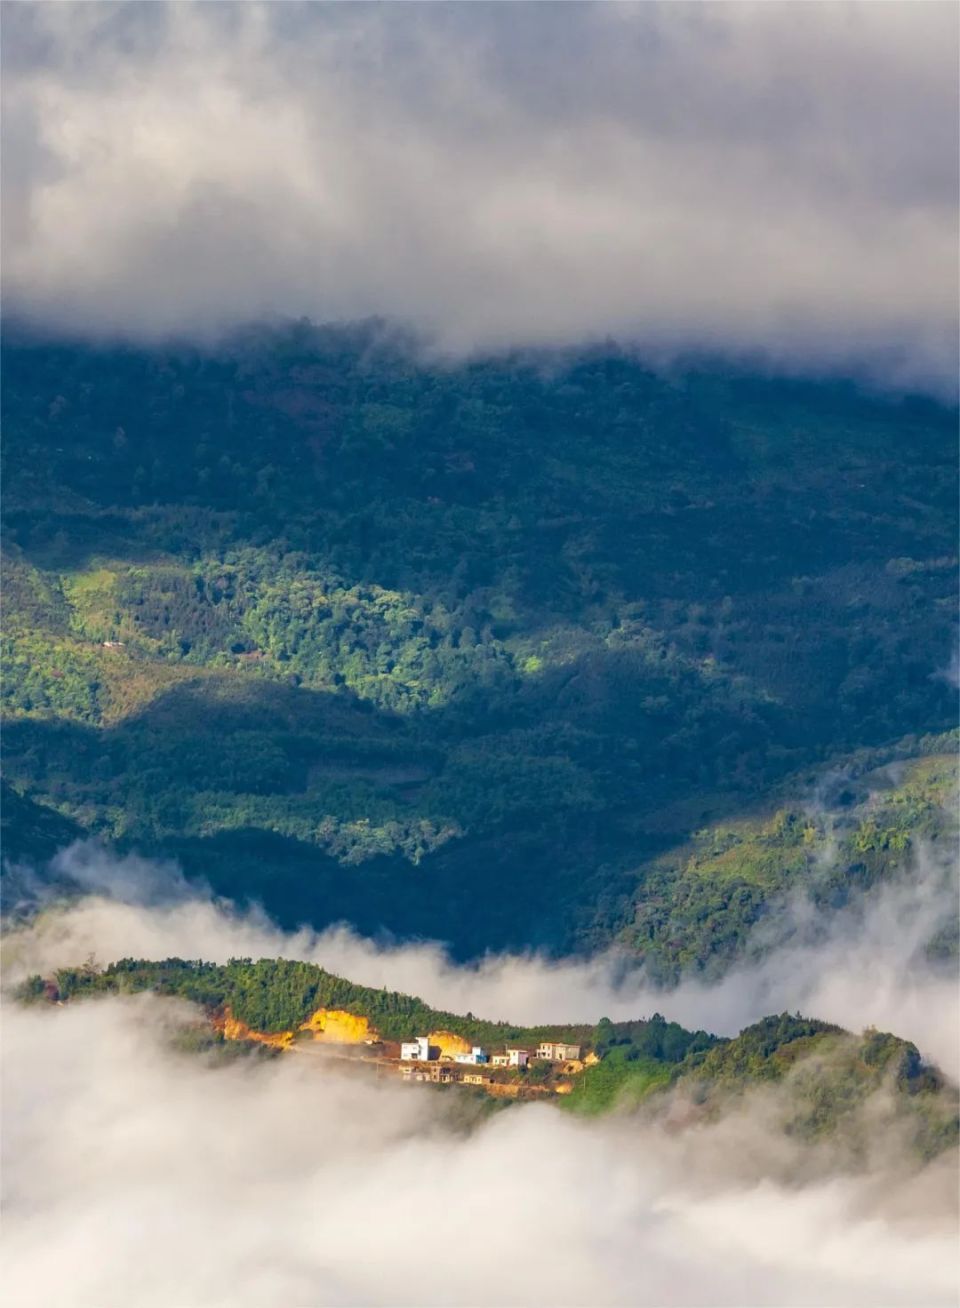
<box><xmin>4</xmin><ymin>844</ymin><xmax>960</xmax><ymax>1078</ymax></box>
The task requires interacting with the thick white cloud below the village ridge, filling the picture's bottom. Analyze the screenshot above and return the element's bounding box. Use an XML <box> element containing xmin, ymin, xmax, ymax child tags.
<box><xmin>3</xmin><ymin>995</ymin><xmax>956</xmax><ymax>1308</ymax></box>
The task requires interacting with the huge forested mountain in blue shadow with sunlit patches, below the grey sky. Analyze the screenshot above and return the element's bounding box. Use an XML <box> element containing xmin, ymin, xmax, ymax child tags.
<box><xmin>3</xmin><ymin>323</ymin><xmax>956</xmax><ymax>962</ymax></box>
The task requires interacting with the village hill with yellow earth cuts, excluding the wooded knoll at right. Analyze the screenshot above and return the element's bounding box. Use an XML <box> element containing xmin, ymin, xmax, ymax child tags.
<box><xmin>24</xmin><ymin>959</ymin><xmax>723</xmax><ymax>1112</ymax></box>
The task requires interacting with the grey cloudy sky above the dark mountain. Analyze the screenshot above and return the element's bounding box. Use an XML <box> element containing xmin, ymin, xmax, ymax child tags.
<box><xmin>3</xmin><ymin>3</ymin><xmax>957</xmax><ymax>394</ymax></box>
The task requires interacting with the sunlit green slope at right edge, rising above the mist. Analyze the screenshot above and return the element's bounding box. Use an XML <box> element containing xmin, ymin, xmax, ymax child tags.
<box><xmin>620</xmin><ymin>736</ymin><xmax>957</xmax><ymax>981</ymax></box>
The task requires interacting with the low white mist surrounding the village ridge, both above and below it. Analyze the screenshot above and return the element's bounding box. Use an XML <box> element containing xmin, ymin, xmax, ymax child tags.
<box><xmin>3</xmin><ymin>842</ymin><xmax>957</xmax><ymax>1308</ymax></box>
